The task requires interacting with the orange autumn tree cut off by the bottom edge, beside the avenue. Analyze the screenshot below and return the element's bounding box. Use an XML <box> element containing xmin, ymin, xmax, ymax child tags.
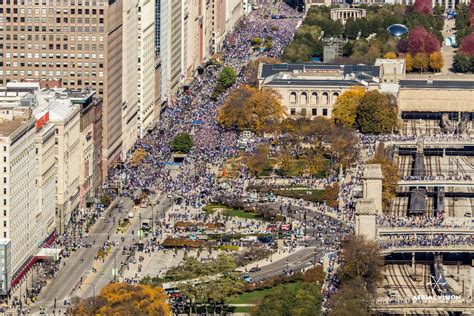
<box><xmin>73</xmin><ymin>283</ymin><xmax>171</xmax><ymax>316</ymax></box>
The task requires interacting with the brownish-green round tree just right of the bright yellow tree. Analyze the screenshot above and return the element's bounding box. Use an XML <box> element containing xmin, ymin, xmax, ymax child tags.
<box><xmin>356</xmin><ymin>90</ymin><xmax>398</xmax><ymax>134</ymax></box>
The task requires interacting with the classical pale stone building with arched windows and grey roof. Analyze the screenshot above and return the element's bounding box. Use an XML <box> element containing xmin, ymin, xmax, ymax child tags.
<box><xmin>258</xmin><ymin>63</ymin><xmax>380</xmax><ymax>118</ymax></box>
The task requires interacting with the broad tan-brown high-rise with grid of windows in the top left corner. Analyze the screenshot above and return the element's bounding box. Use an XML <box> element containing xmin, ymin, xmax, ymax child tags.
<box><xmin>0</xmin><ymin>0</ymin><xmax>122</xmax><ymax>173</ymax></box>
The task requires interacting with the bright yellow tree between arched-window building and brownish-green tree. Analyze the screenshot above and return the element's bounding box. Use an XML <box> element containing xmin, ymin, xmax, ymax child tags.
<box><xmin>332</xmin><ymin>87</ymin><xmax>365</xmax><ymax>128</ymax></box>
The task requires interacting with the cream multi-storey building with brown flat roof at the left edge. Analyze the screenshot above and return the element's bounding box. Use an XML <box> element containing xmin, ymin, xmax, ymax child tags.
<box><xmin>0</xmin><ymin>108</ymin><xmax>48</xmax><ymax>279</ymax></box>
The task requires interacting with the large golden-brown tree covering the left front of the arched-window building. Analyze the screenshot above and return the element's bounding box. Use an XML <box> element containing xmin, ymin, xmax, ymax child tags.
<box><xmin>217</xmin><ymin>86</ymin><xmax>286</xmax><ymax>134</ymax></box>
